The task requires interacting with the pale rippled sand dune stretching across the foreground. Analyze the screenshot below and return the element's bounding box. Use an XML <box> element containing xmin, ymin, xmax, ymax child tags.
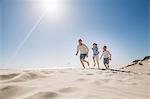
<box><xmin>0</xmin><ymin>60</ymin><xmax>150</xmax><ymax>99</ymax></box>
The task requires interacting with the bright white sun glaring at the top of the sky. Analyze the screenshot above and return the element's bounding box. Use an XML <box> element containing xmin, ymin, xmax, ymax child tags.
<box><xmin>36</xmin><ymin>0</ymin><xmax>67</xmax><ymax>20</ymax></box>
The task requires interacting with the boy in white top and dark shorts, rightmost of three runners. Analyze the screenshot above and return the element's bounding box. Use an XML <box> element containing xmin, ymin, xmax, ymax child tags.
<box><xmin>100</xmin><ymin>46</ymin><xmax>111</xmax><ymax>69</ymax></box>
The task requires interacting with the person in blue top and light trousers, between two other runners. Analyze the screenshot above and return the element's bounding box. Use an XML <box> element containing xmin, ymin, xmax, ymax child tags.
<box><xmin>92</xmin><ymin>43</ymin><xmax>100</xmax><ymax>69</ymax></box>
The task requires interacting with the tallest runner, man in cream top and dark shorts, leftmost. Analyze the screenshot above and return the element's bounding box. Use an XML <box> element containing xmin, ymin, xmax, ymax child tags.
<box><xmin>76</xmin><ymin>39</ymin><xmax>89</xmax><ymax>68</ymax></box>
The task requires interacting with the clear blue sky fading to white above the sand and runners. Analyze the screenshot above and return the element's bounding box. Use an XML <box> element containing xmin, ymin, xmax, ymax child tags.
<box><xmin>0</xmin><ymin>0</ymin><xmax>150</xmax><ymax>68</ymax></box>
